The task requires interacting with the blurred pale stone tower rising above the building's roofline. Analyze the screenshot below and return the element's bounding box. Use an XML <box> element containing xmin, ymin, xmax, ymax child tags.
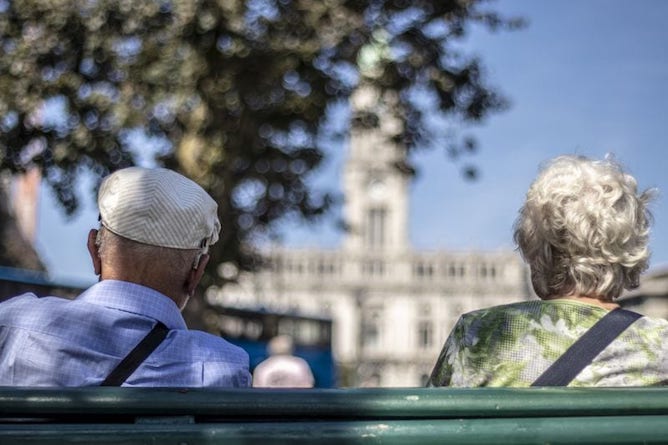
<box><xmin>343</xmin><ymin>85</ymin><xmax>411</xmax><ymax>254</ymax></box>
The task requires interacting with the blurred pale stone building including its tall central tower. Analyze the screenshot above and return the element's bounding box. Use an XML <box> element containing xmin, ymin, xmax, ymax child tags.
<box><xmin>207</xmin><ymin>89</ymin><xmax>530</xmax><ymax>387</ymax></box>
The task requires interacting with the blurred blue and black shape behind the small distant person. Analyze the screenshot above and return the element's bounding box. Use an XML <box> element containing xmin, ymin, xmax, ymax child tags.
<box><xmin>206</xmin><ymin>307</ymin><xmax>337</xmax><ymax>388</ymax></box>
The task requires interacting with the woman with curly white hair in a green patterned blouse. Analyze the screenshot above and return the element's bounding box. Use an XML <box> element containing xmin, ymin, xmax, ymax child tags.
<box><xmin>428</xmin><ymin>156</ymin><xmax>668</xmax><ymax>386</ymax></box>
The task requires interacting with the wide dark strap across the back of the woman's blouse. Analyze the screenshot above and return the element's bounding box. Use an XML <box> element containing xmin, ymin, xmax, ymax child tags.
<box><xmin>531</xmin><ymin>308</ymin><xmax>642</xmax><ymax>386</ymax></box>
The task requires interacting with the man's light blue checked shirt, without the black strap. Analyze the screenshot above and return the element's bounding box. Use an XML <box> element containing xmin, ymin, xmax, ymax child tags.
<box><xmin>0</xmin><ymin>280</ymin><xmax>251</xmax><ymax>387</ymax></box>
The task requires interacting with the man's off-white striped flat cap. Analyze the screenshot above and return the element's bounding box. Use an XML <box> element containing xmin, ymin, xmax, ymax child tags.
<box><xmin>97</xmin><ymin>167</ymin><xmax>220</xmax><ymax>249</ymax></box>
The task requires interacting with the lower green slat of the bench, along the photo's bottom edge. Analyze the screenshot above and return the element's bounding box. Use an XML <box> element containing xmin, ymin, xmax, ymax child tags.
<box><xmin>0</xmin><ymin>416</ymin><xmax>668</xmax><ymax>445</ymax></box>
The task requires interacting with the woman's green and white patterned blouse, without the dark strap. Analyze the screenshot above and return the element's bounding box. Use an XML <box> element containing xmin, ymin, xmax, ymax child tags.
<box><xmin>427</xmin><ymin>300</ymin><xmax>668</xmax><ymax>387</ymax></box>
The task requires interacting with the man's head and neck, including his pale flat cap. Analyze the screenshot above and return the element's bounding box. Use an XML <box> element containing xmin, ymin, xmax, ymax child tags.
<box><xmin>88</xmin><ymin>167</ymin><xmax>220</xmax><ymax>309</ymax></box>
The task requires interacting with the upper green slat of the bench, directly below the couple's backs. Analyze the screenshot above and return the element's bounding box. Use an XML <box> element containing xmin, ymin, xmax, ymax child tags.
<box><xmin>0</xmin><ymin>387</ymin><xmax>668</xmax><ymax>420</ymax></box>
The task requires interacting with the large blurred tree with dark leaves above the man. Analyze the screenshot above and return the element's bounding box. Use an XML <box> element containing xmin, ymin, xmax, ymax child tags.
<box><xmin>0</xmin><ymin>0</ymin><xmax>520</xmax><ymax>285</ymax></box>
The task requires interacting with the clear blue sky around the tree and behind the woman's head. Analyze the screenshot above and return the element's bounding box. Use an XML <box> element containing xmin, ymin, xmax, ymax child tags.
<box><xmin>38</xmin><ymin>0</ymin><xmax>668</xmax><ymax>282</ymax></box>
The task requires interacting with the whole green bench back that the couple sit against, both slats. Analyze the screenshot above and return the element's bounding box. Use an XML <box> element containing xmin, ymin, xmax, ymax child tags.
<box><xmin>0</xmin><ymin>387</ymin><xmax>668</xmax><ymax>445</ymax></box>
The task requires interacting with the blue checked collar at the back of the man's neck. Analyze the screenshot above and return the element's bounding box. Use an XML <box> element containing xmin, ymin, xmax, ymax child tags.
<box><xmin>77</xmin><ymin>280</ymin><xmax>187</xmax><ymax>329</ymax></box>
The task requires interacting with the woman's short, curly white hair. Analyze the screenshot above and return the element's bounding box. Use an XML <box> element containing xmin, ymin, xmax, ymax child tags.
<box><xmin>514</xmin><ymin>156</ymin><xmax>655</xmax><ymax>301</ymax></box>
